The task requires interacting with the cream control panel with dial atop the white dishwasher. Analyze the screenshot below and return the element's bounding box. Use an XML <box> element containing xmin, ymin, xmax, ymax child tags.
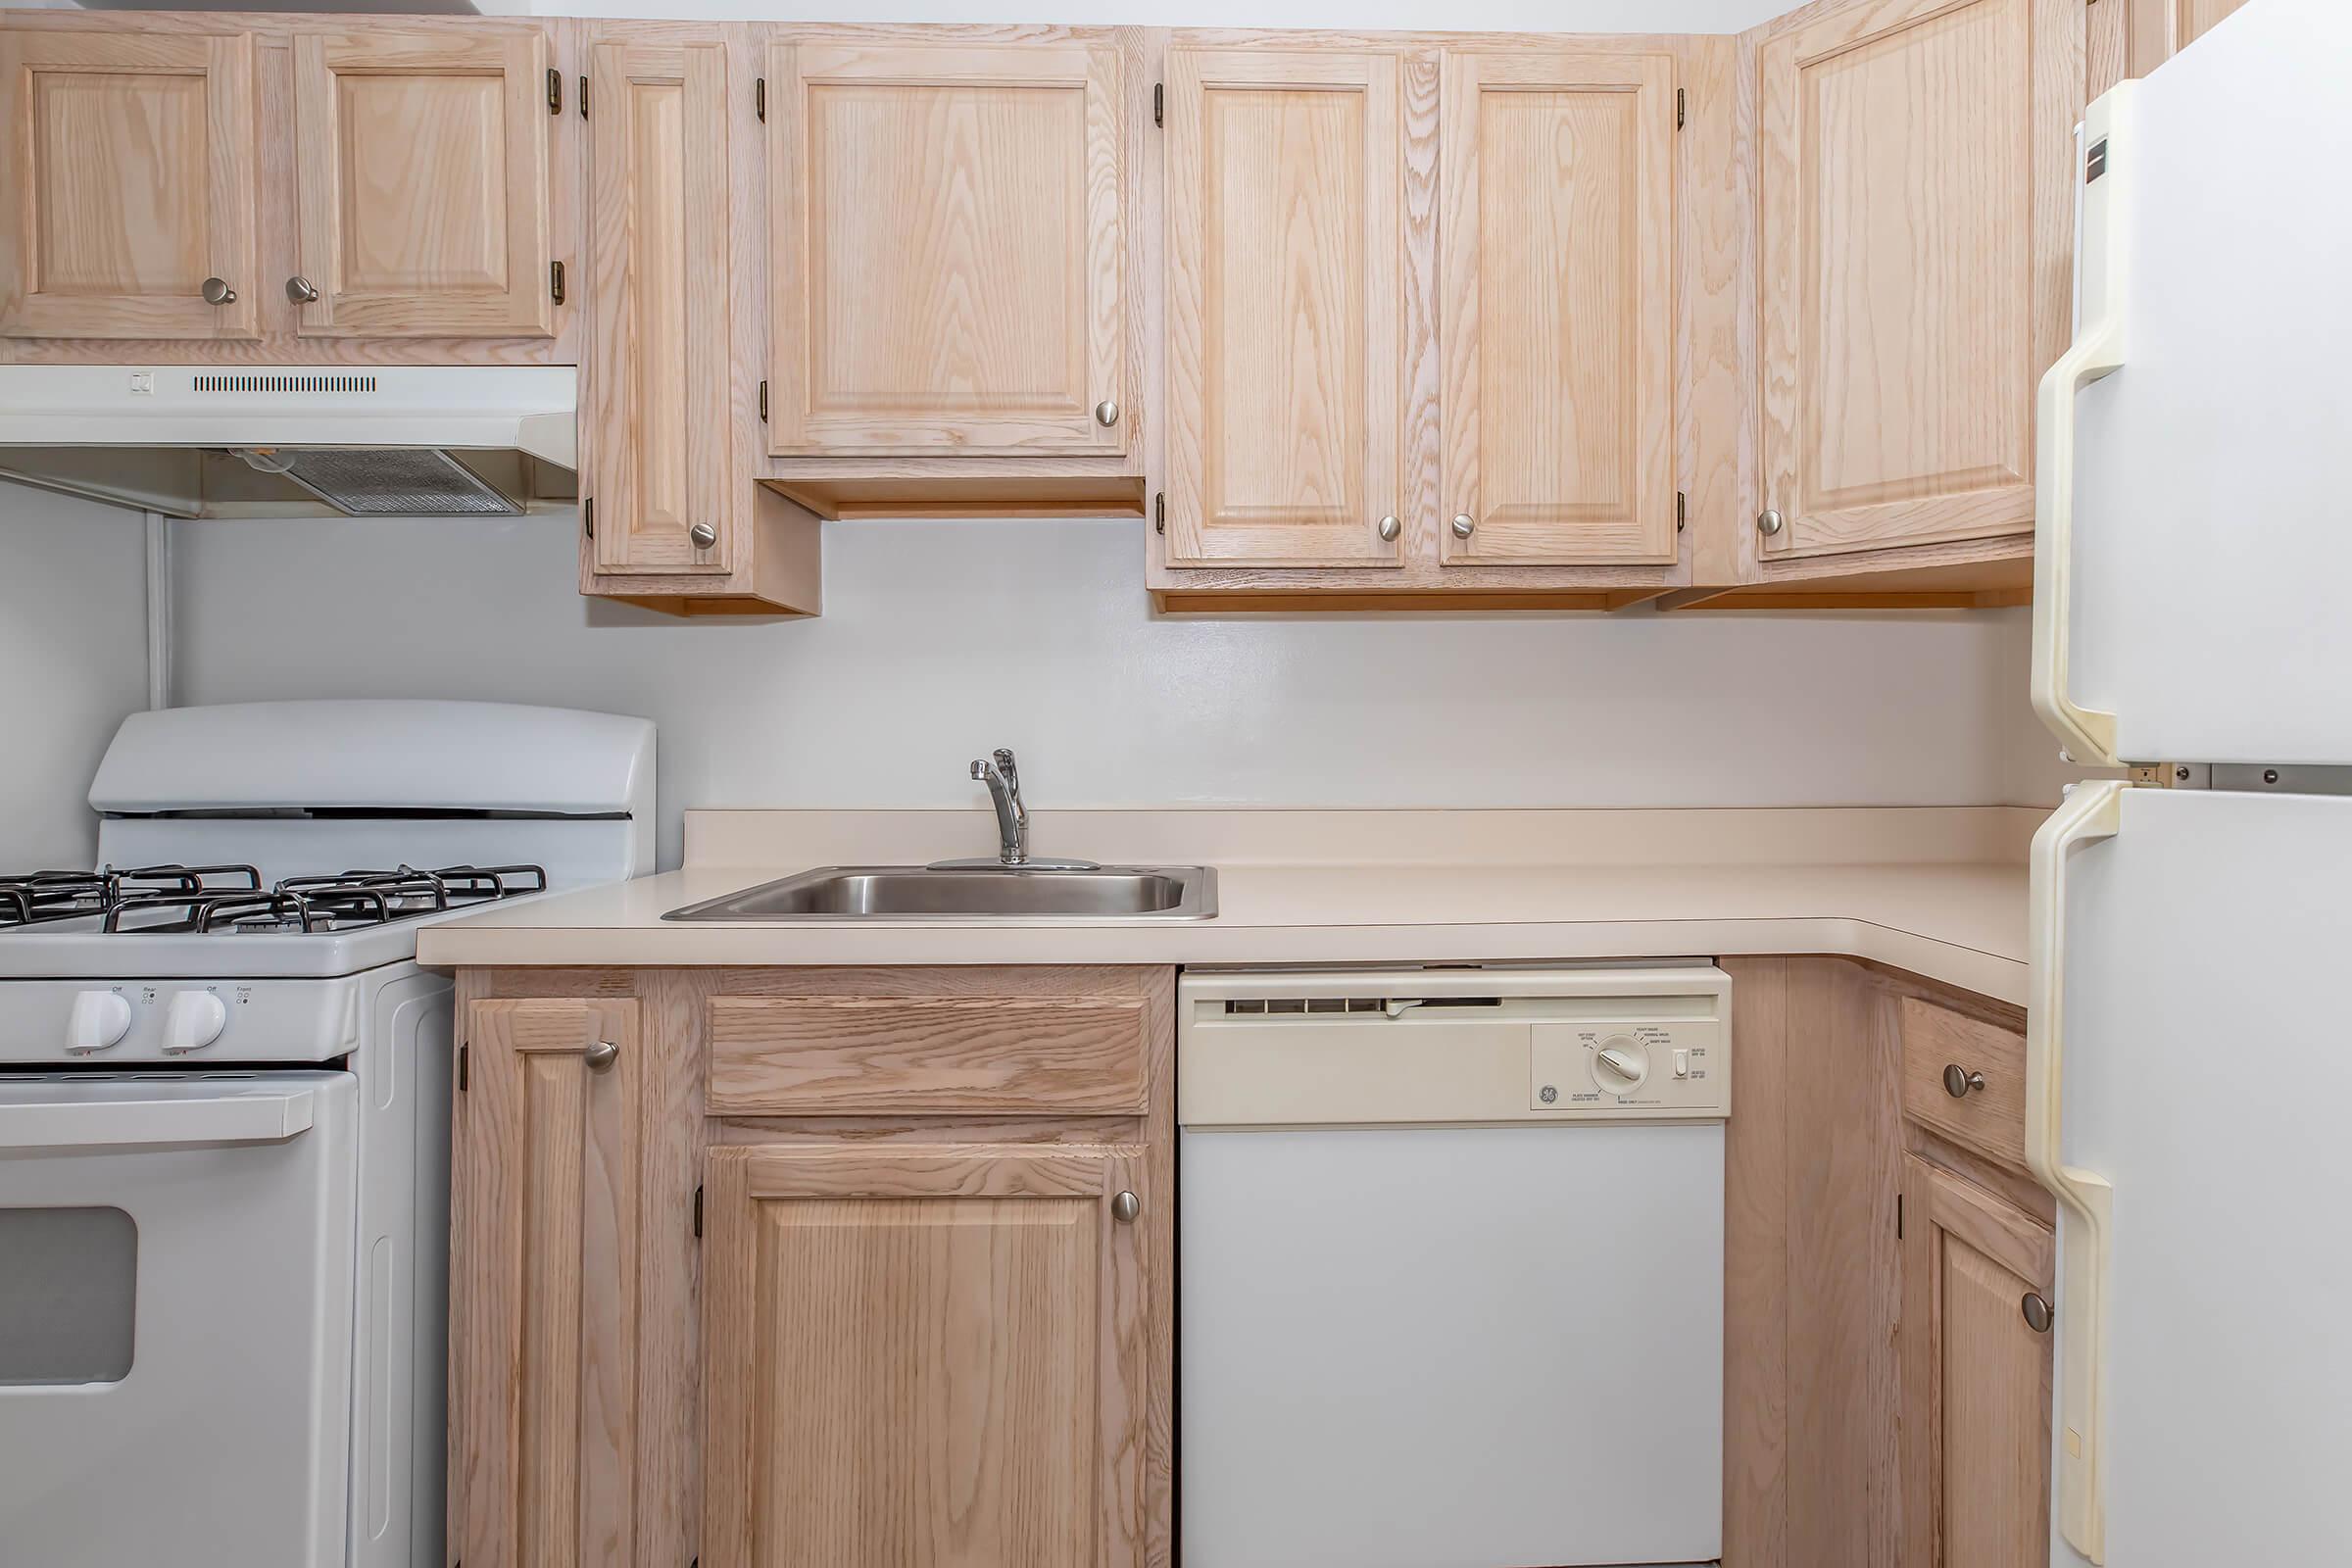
<box><xmin>1176</xmin><ymin>964</ymin><xmax>1731</xmax><ymax>1128</ymax></box>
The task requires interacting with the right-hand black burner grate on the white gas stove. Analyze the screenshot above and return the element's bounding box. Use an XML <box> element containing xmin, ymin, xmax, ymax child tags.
<box><xmin>101</xmin><ymin>865</ymin><xmax>548</xmax><ymax>936</ymax></box>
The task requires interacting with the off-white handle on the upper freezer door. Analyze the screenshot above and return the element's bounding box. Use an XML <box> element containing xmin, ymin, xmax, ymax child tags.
<box><xmin>2033</xmin><ymin>82</ymin><xmax>2138</xmax><ymax>766</ymax></box>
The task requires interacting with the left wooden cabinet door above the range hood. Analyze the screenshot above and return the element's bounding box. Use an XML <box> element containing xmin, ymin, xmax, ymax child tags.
<box><xmin>0</xmin><ymin>28</ymin><xmax>261</xmax><ymax>338</ymax></box>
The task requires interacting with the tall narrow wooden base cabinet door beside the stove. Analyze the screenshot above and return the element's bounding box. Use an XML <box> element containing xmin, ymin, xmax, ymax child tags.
<box><xmin>449</xmin><ymin>997</ymin><xmax>642</xmax><ymax>1568</ymax></box>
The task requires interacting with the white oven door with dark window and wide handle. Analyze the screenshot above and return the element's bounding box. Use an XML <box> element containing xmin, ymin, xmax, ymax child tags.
<box><xmin>0</xmin><ymin>1072</ymin><xmax>358</xmax><ymax>1568</ymax></box>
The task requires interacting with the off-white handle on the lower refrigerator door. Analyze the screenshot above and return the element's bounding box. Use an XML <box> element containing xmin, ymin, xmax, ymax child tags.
<box><xmin>2025</xmin><ymin>778</ymin><xmax>2127</xmax><ymax>1563</ymax></box>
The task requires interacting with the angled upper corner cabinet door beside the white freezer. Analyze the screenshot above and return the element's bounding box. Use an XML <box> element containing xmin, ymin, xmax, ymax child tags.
<box><xmin>1757</xmin><ymin>0</ymin><xmax>2086</xmax><ymax>560</ymax></box>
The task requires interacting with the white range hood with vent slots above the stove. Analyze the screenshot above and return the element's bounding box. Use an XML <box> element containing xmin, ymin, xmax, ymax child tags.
<box><xmin>0</xmin><ymin>365</ymin><xmax>578</xmax><ymax>517</ymax></box>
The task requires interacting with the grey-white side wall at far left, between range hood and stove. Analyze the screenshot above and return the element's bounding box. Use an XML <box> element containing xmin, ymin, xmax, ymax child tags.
<box><xmin>0</xmin><ymin>484</ymin><xmax>146</xmax><ymax>870</ymax></box>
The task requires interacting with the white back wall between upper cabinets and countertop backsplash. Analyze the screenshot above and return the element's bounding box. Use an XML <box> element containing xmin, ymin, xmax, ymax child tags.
<box><xmin>172</xmin><ymin>514</ymin><xmax>2018</xmax><ymax>862</ymax></box>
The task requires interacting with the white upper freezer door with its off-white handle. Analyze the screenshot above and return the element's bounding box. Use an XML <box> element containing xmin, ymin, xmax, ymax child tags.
<box><xmin>2034</xmin><ymin>0</ymin><xmax>2352</xmax><ymax>764</ymax></box>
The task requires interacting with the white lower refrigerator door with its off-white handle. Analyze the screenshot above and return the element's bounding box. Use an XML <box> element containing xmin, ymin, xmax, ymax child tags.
<box><xmin>2028</xmin><ymin>789</ymin><xmax>2352</xmax><ymax>1568</ymax></box>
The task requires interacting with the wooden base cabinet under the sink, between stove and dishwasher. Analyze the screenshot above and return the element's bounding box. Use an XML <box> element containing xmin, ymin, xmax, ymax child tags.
<box><xmin>449</xmin><ymin>966</ymin><xmax>1176</xmax><ymax>1568</ymax></box>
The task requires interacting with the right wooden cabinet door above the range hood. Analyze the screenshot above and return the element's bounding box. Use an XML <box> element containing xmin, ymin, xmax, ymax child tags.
<box><xmin>280</xmin><ymin>28</ymin><xmax>555</xmax><ymax>338</ymax></box>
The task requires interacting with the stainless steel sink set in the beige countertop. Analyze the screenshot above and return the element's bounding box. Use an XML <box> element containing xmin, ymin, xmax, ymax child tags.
<box><xmin>661</xmin><ymin>865</ymin><xmax>1216</xmax><ymax>921</ymax></box>
